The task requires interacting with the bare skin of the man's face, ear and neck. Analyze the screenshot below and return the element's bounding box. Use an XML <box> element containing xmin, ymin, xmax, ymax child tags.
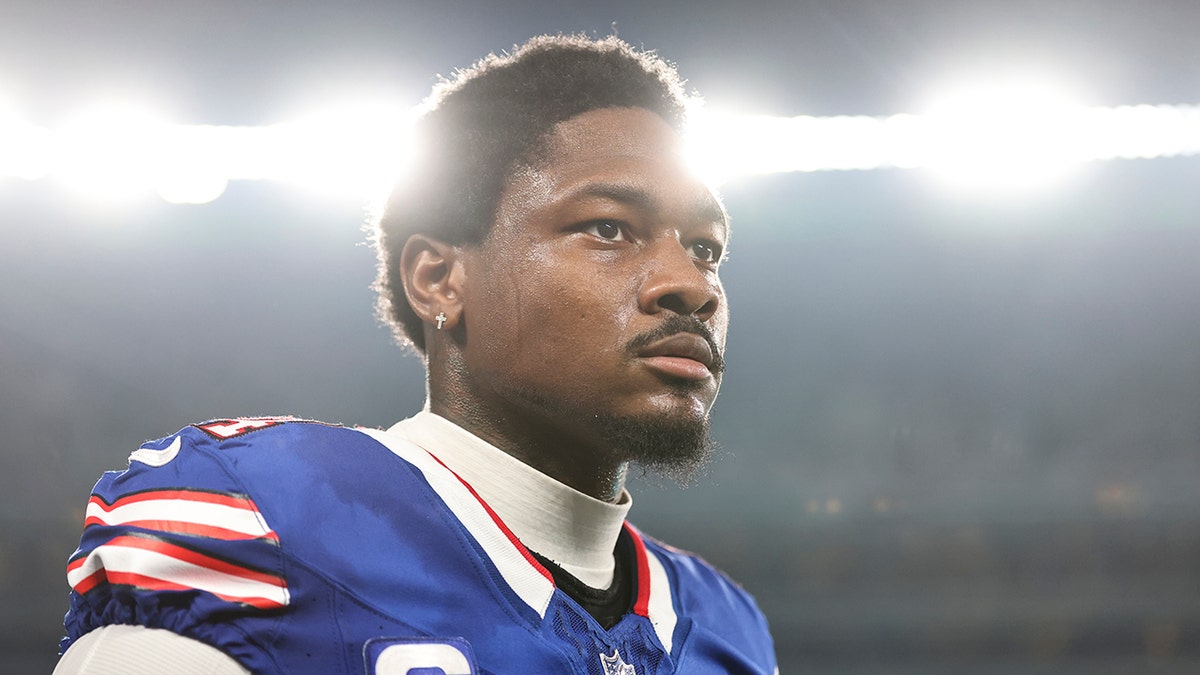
<box><xmin>402</xmin><ymin>108</ymin><xmax>728</xmax><ymax>501</ymax></box>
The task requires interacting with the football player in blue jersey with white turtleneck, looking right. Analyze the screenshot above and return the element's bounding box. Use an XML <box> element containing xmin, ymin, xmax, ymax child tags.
<box><xmin>59</xmin><ymin>37</ymin><xmax>775</xmax><ymax>675</ymax></box>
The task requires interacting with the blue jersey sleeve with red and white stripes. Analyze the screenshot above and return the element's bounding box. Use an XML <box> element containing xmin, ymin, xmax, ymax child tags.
<box><xmin>60</xmin><ymin>428</ymin><xmax>289</xmax><ymax>665</ymax></box>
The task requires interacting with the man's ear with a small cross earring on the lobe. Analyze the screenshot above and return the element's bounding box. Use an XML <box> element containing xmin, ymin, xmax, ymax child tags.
<box><xmin>400</xmin><ymin>234</ymin><xmax>467</xmax><ymax>329</ymax></box>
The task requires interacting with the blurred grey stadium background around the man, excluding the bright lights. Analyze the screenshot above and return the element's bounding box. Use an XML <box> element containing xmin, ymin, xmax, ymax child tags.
<box><xmin>0</xmin><ymin>0</ymin><xmax>1200</xmax><ymax>674</ymax></box>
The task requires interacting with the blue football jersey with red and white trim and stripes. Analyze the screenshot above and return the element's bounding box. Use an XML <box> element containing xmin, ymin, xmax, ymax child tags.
<box><xmin>61</xmin><ymin>418</ymin><xmax>775</xmax><ymax>675</ymax></box>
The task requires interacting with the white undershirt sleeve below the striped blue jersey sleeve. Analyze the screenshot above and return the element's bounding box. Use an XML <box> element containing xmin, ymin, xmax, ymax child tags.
<box><xmin>54</xmin><ymin>625</ymin><xmax>250</xmax><ymax>675</ymax></box>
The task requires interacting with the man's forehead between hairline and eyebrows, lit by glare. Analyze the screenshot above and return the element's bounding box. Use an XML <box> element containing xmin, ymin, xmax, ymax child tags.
<box><xmin>509</xmin><ymin>108</ymin><xmax>727</xmax><ymax>225</ymax></box>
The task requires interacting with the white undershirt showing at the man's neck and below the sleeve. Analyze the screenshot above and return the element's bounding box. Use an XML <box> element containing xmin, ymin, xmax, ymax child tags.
<box><xmin>54</xmin><ymin>411</ymin><xmax>634</xmax><ymax>675</ymax></box>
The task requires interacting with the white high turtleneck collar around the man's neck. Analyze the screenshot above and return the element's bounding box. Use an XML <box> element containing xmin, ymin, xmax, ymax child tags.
<box><xmin>388</xmin><ymin>411</ymin><xmax>634</xmax><ymax>589</ymax></box>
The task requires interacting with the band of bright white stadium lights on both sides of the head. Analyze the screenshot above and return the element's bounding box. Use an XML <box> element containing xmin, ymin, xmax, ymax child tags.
<box><xmin>9</xmin><ymin>85</ymin><xmax>1200</xmax><ymax>204</ymax></box>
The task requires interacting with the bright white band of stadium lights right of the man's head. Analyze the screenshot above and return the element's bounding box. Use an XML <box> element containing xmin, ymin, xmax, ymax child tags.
<box><xmin>688</xmin><ymin>86</ymin><xmax>1200</xmax><ymax>189</ymax></box>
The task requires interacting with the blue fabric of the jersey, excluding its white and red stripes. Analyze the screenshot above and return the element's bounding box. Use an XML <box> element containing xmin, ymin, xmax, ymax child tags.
<box><xmin>61</xmin><ymin>420</ymin><xmax>775</xmax><ymax>675</ymax></box>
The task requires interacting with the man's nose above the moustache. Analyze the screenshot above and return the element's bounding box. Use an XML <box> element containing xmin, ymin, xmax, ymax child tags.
<box><xmin>637</xmin><ymin>237</ymin><xmax>725</xmax><ymax>322</ymax></box>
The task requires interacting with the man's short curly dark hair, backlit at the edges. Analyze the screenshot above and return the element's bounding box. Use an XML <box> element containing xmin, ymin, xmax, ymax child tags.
<box><xmin>373</xmin><ymin>35</ymin><xmax>689</xmax><ymax>354</ymax></box>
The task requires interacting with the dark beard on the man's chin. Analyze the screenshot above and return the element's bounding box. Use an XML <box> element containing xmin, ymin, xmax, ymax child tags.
<box><xmin>594</xmin><ymin>403</ymin><xmax>716</xmax><ymax>486</ymax></box>
